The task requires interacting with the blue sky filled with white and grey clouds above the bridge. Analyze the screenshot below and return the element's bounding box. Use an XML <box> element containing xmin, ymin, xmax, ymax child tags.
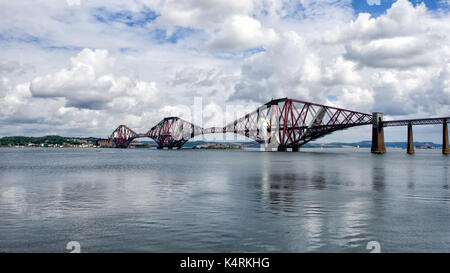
<box><xmin>0</xmin><ymin>0</ymin><xmax>450</xmax><ymax>143</ymax></box>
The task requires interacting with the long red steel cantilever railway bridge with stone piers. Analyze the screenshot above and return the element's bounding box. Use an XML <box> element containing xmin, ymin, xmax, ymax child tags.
<box><xmin>109</xmin><ymin>98</ymin><xmax>450</xmax><ymax>154</ymax></box>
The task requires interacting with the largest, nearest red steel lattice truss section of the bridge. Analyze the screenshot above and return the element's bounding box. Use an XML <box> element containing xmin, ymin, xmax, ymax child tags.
<box><xmin>224</xmin><ymin>98</ymin><xmax>372</xmax><ymax>148</ymax></box>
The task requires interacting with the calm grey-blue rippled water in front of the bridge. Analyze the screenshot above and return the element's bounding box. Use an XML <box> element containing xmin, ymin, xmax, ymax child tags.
<box><xmin>0</xmin><ymin>148</ymin><xmax>450</xmax><ymax>252</ymax></box>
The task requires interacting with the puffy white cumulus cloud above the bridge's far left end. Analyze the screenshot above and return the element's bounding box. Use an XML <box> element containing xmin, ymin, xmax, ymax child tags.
<box><xmin>30</xmin><ymin>49</ymin><xmax>158</xmax><ymax>109</ymax></box>
